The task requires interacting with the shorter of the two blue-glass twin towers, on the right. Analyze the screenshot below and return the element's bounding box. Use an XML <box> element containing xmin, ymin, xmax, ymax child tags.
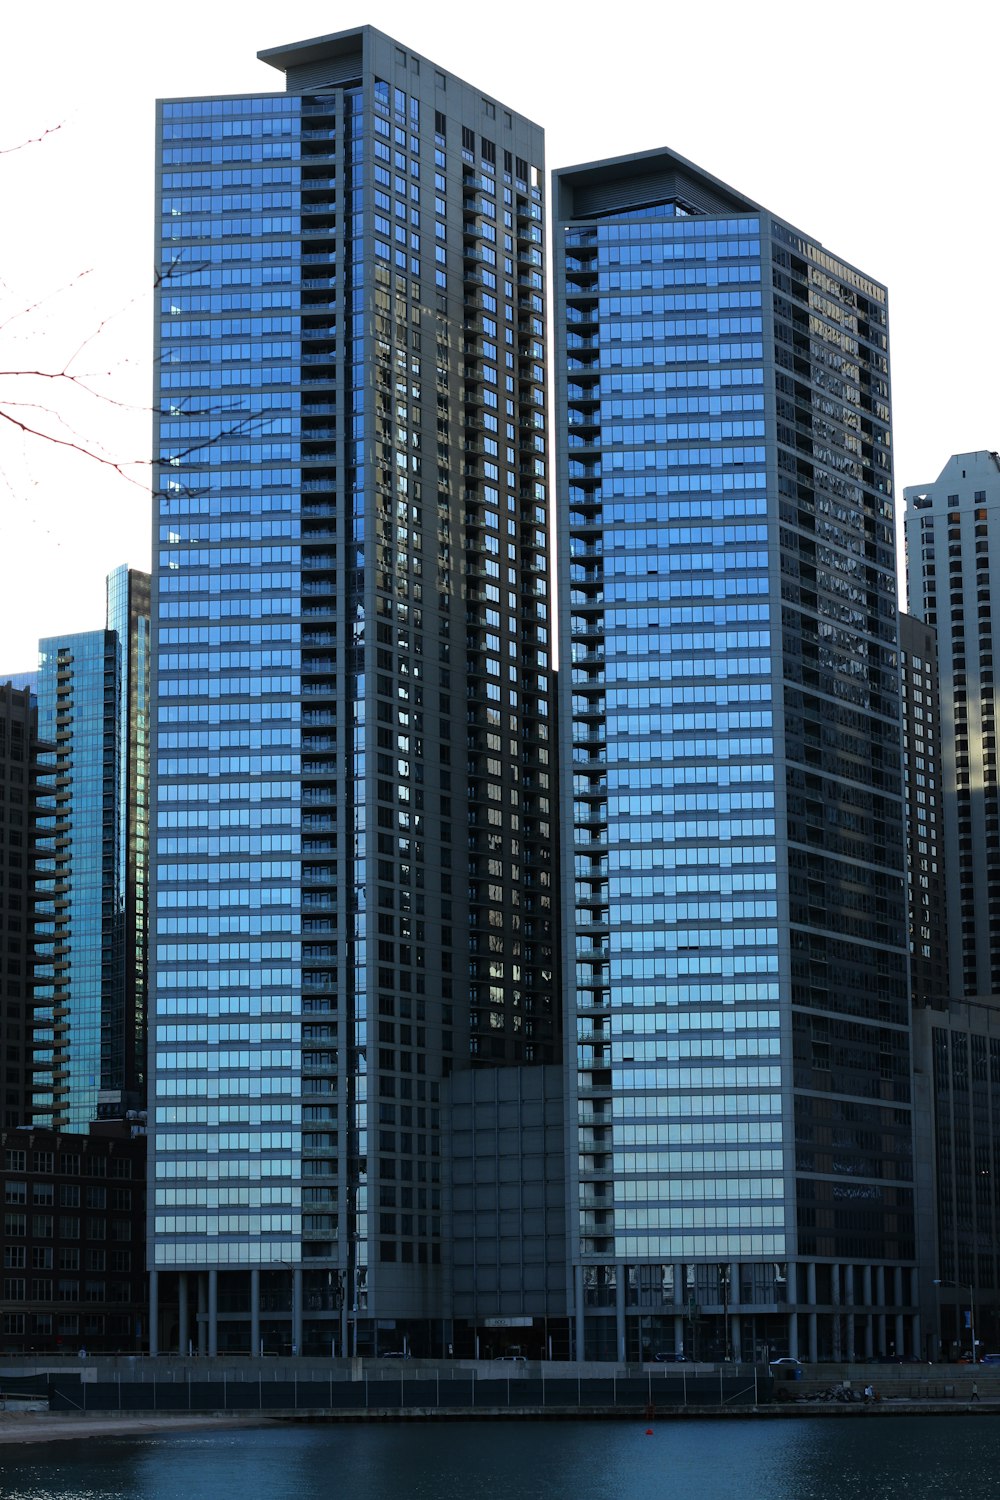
<box><xmin>553</xmin><ymin>152</ymin><xmax>921</xmax><ymax>1359</ymax></box>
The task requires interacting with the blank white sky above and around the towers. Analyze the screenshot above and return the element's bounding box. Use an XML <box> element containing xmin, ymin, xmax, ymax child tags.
<box><xmin>0</xmin><ymin>0</ymin><xmax>1000</xmax><ymax>672</ymax></box>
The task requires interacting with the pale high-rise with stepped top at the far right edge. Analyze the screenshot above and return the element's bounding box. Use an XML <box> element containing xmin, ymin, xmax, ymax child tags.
<box><xmin>904</xmin><ymin>452</ymin><xmax>1000</xmax><ymax>998</ymax></box>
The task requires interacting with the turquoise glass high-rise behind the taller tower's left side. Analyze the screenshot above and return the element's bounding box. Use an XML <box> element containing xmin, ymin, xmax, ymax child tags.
<box><xmin>33</xmin><ymin>569</ymin><xmax>148</xmax><ymax>1131</ymax></box>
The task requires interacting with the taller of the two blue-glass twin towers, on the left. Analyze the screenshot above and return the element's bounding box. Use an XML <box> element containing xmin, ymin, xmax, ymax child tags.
<box><xmin>150</xmin><ymin>27</ymin><xmax>558</xmax><ymax>1353</ymax></box>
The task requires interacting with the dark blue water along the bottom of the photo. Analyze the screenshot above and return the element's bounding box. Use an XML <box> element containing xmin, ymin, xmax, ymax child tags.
<box><xmin>0</xmin><ymin>1413</ymin><xmax>1000</xmax><ymax>1500</ymax></box>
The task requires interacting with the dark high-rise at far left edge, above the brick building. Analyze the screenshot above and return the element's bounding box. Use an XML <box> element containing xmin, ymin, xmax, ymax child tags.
<box><xmin>0</xmin><ymin>681</ymin><xmax>46</xmax><ymax>1127</ymax></box>
